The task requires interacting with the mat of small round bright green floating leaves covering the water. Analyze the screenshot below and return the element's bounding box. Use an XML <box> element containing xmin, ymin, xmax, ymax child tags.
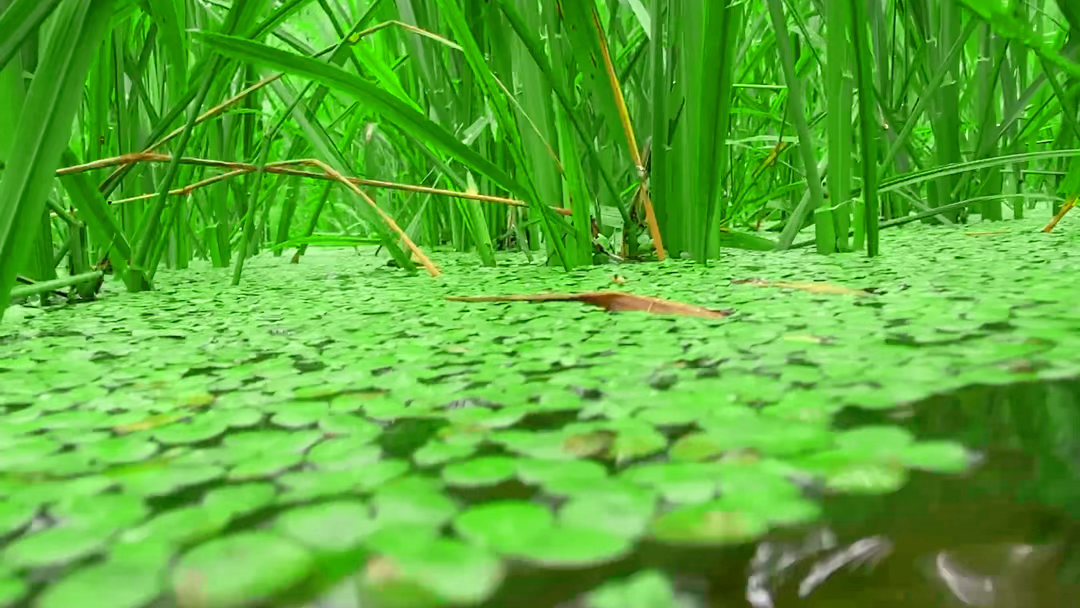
<box><xmin>0</xmin><ymin>215</ymin><xmax>1080</xmax><ymax>608</ymax></box>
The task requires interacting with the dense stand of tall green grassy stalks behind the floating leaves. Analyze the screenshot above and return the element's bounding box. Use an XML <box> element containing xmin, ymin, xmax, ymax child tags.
<box><xmin>0</xmin><ymin>0</ymin><xmax>1080</xmax><ymax>319</ymax></box>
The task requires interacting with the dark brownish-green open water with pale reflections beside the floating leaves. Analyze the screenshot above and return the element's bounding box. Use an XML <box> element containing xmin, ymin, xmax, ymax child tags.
<box><xmin>440</xmin><ymin>382</ymin><xmax>1080</xmax><ymax>608</ymax></box>
